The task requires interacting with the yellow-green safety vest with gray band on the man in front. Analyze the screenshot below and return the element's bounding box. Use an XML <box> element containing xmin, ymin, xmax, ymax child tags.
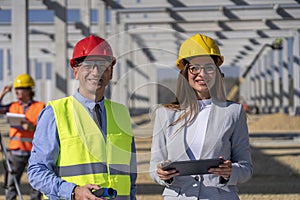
<box><xmin>49</xmin><ymin>96</ymin><xmax>133</xmax><ymax>197</ymax></box>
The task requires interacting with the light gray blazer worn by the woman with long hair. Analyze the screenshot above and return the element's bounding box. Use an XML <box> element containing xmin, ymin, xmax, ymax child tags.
<box><xmin>149</xmin><ymin>102</ymin><xmax>253</xmax><ymax>200</ymax></box>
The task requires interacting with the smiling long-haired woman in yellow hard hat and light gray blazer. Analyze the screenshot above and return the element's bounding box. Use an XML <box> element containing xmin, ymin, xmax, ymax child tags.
<box><xmin>150</xmin><ymin>34</ymin><xmax>253</xmax><ymax>200</ymax></box>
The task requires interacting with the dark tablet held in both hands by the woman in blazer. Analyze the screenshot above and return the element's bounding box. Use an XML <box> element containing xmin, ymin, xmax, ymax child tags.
<box><xmin>162</xmin><ymin>158</ymin><xmax>224</xmax><ymax>176</ymax></box>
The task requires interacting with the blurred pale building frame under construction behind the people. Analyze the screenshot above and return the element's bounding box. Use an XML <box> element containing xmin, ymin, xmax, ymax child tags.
<box><xmin>0</xmin><ymin>0</ymin><xmax>300</xmax><ymax>115</ymax></box>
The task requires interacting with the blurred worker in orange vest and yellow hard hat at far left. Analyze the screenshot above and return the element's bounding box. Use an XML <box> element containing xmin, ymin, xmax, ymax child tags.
<box><xmin>0</xmin><ymin>74</ymin><xmax>45</xmax><ymax>200</ymax></box>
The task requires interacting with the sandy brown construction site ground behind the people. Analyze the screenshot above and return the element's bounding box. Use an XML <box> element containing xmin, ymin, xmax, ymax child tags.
<box><xmin>0</xmin><ymin>114</ymin><xmax>300</xmax><ymax>200</ymax></box>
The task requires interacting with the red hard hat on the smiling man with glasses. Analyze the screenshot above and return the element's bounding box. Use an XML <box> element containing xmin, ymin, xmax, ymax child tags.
<box><xmin>70</xmin><ymin>35</ymin><xmax>116</xmax><ymax>68</ymax></box>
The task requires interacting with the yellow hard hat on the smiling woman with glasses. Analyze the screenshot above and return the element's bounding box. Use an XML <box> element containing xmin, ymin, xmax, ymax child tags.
<box><xmin>176</xmin><ymin>34</ymin><xmax>224</xmax><ymax>70</ymax></box>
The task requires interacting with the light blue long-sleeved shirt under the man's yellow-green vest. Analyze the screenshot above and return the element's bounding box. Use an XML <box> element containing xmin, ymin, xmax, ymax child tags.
<box><xmin>28</xmin><ymin>91</ymin><xmax>137</xmax><ymax>199</ymax></box>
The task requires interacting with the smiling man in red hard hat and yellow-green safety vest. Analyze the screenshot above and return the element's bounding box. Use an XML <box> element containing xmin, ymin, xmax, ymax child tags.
<box><xmin>28</xmin><ymin>35</ymin><xmax>136</xmax><ymax>200</ymax></box>
